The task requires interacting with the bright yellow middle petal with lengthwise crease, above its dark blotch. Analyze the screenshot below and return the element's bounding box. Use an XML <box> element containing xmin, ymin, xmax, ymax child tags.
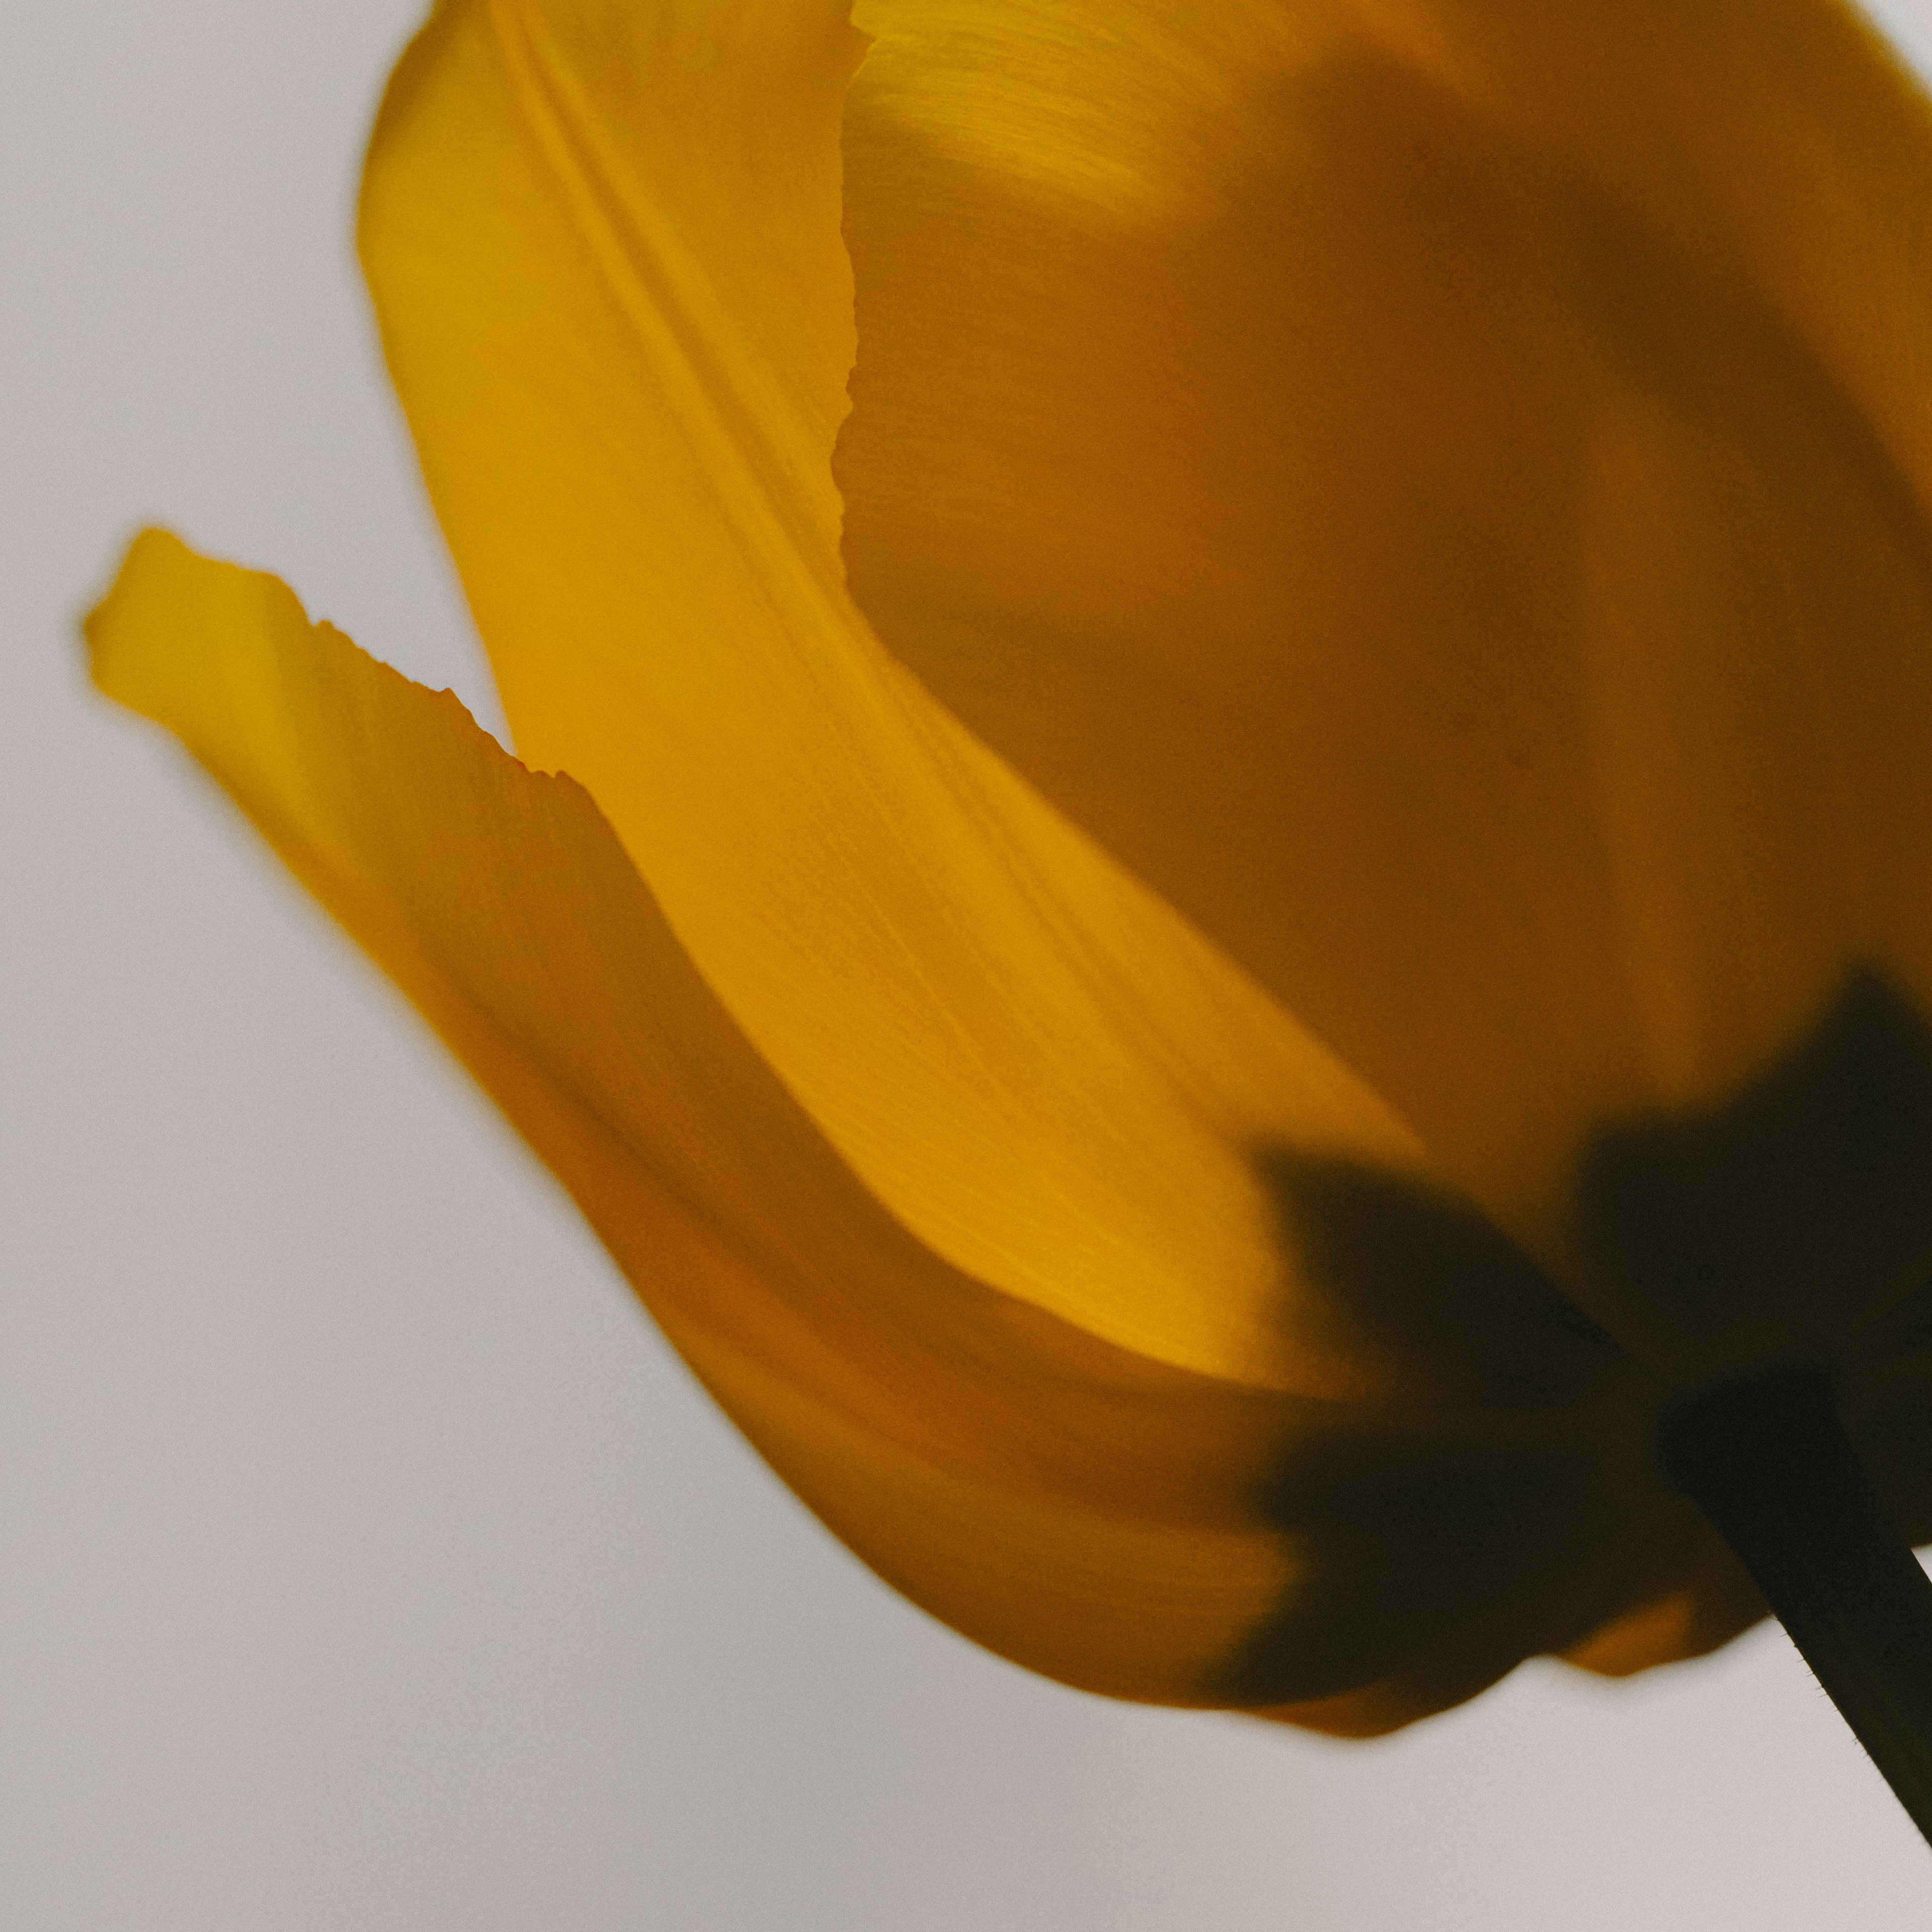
<box><xmin>361</xmin><ymin>0</ymin><xmax>1507</xmax><ymax>1393</ymax></box>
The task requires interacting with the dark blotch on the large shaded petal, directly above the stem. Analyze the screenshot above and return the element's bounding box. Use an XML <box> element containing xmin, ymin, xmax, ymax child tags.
<box><xmin>1576</xmin><ymin>966</ymin><xmax>1932</xmax><ymax>1362</ymax></box>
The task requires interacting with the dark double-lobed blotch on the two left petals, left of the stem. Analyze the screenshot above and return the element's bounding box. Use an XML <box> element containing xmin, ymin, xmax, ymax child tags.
<box><xmin>1208</xmin><ymin>1148</ymin><xmax>1631</xmax><ymax>1706</ymax></box>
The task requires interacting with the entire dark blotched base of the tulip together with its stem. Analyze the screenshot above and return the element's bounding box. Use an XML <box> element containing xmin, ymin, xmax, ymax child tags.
<box><xmin>1212</xmin><ymin>966</ymin><xmax>1932</xmax><ymax>1837</ymax></box>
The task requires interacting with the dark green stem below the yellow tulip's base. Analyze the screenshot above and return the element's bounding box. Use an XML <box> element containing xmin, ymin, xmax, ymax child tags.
<box><xmin>1658</xmin><ymin>1368</ymin><xmax>1932</xmax><ymax>1843</ymax></box>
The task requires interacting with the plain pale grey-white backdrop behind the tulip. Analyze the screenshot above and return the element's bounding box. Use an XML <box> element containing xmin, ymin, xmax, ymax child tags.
<box><xmin>11</xmin><ymin>0</ymin><xmax>1932</xmax><ymax>1932</ymax></box>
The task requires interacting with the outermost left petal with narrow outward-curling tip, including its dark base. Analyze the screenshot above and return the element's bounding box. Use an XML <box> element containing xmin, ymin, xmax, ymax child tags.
<box><xmin>89</xmin><ymin>533</ymin><xmax>1648</xmax><ymax>1714</ymax></box>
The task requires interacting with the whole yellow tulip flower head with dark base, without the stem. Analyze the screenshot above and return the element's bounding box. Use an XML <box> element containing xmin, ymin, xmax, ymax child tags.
<box><xmin>91</xmin><ymin>0</ymin><xmax>1932</xmax><ymax>1733</ymax></box>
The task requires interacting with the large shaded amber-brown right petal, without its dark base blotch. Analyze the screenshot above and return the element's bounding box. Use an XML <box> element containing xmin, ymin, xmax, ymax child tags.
<box><xmin>837</xmin><ymin>0</ymin><xmax>1932</xmax><ymax>1372</ymax></box>
